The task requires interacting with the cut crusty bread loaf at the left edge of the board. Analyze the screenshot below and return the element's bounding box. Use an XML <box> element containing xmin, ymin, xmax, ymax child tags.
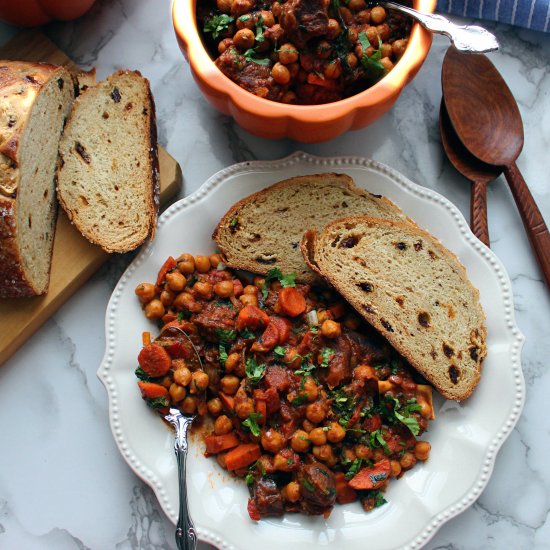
<box><xmin>0</xmin><ymin>61</ymin><xmax>75</xmax><ymax>298</ymax></box>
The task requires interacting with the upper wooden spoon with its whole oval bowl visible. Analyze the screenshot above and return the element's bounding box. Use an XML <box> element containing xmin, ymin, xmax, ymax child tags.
<box><xmin>441</xmin><ymin>47</ymin><xmax>550</xmax><ymax>287</ymax></box>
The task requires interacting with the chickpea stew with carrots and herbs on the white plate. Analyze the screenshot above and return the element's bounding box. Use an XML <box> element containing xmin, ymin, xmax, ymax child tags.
<box><xmin>135</xmin><ymin>254</ymin><xmax>434</xmax><ymax>520</ymax></box>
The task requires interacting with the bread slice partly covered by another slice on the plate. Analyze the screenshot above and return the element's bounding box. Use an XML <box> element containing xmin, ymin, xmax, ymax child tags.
<box><xmin>212</xmin><ymin>174</ymin><xmax>407</xmax><ymax>283</ymax></box>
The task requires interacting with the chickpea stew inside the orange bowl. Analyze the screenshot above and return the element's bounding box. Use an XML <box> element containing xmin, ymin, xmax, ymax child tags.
<box><xmin>197</xmin><ymin>0</ymin><xmax>411</xmax><ymax>105</ymax></box>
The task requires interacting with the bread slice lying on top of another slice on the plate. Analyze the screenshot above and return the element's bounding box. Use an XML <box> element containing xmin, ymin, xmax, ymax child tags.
<box><xmin>302</xmin><ymin>216</ymin><xmax>486</xmax><ymax>400</ymax></box>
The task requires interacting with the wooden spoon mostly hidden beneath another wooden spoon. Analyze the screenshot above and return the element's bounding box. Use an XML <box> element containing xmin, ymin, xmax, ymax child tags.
<box><xmin>439</xmin><ymin>99</ymin><xmax>502</xmax><ymax>246</ymax></box>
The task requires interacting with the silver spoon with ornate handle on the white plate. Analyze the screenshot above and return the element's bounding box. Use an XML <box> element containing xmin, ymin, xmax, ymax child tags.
<box><xmin>161</xmin><ymin>327</ymin><xmax>202</xmax><ymax>550</ymax></box>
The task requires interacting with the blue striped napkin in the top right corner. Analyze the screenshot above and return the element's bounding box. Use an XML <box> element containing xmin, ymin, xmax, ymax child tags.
<box><xmin>437</xmin><ymin>0</ymin><xmax>550</xmax><ymax>32</ymax></box>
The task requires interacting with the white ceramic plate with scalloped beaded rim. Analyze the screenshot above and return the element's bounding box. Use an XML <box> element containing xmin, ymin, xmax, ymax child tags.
<box><xmin>98</xmin><ymin>153</ymin><xmax>525</xmax><ymax>550</ymax></box>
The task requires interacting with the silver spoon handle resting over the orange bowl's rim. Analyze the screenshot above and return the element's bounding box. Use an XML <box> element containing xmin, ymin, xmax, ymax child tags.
<box><xmin>380</xmin><ymin>2</ymin><xmax>499</xmax><ymax>53</ymax></box>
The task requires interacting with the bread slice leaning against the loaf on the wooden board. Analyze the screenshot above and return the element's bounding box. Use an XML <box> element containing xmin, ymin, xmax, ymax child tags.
<box><xmin>57</xmin><ymin>71</ymin><xmax>159</xmax><ymax>252</ymax></box>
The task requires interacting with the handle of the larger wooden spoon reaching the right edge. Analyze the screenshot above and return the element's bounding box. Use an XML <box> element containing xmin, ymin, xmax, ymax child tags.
<box><xmin>504</xmin><ymin>162</ymin><xmax>550</xmax><ymax>288</ymax></box>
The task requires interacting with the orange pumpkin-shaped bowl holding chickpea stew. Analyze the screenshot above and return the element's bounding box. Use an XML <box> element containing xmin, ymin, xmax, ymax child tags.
<box><xmin>172</xmin><ymin>0</ymin><xmax>436</xmax><ymax>143</ymax></box>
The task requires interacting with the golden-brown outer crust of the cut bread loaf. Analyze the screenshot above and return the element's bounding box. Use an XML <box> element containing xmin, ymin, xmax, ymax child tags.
<box><xmin>0</xmin><ymin>61</ymin><xmax>72</xmax><ymax>298</ymax></box>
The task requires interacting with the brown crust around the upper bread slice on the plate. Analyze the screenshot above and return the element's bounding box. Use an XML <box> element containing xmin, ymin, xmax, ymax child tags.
<box><xmin>301</xmin><ymin>216</ymin><xmax>487</xmax><ymax>400</ymax></box>
